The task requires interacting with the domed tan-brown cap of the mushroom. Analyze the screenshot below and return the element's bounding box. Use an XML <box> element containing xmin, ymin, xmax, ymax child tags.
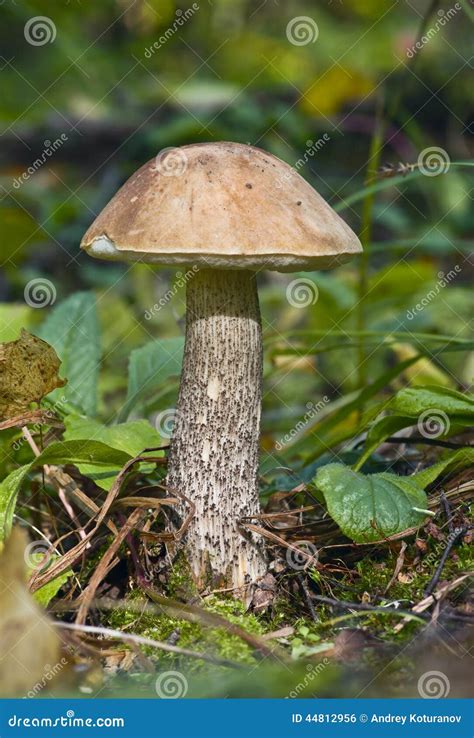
<box><xmin>81</xmin><ymin>142</ymin><xmax>362</xmax><ymax>272</ymax></box>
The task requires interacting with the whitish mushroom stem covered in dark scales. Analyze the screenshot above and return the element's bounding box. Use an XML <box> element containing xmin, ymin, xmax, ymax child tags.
<box><xmin>168</xmin><ymin>269</ymin><xmax>266</xmax><ymax>589</ymax></box>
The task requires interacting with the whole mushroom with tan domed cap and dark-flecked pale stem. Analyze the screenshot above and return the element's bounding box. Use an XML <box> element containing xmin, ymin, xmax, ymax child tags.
<box><xmin>81</xmin><ymin>142</ymin><xmax>361</xmax><ymax>591</ymax></box>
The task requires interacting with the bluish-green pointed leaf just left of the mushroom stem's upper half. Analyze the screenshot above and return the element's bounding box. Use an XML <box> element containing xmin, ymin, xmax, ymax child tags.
<box><xmin>119</xmin><ymin>337</ymin><xmax>184</xmax><ymax>420</ymax></box>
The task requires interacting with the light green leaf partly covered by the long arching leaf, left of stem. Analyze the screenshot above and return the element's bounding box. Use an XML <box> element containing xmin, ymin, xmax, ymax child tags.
<box><xmin>64</xmin><ymin>415</ymin><xmax>160</xmax><ymax>490</ymax></box>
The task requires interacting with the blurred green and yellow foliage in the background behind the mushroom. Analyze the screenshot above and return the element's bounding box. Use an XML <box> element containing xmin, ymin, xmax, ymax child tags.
<box><xmin>0</xmin><ymin>0</ymin><xmax>474</xmax><ymax>472</ymax></box>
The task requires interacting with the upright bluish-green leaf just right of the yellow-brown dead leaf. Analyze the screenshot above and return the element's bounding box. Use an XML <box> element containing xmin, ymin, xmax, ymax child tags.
<box><xmin>37</xmin><ymin>292</ymin><xmax>101</xmax><ymax>415</ymax></box>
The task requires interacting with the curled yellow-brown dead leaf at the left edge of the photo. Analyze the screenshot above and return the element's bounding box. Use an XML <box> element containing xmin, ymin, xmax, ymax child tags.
<box><xmin>0</xmin><ymin>330</ymin><xmax>66</xmax><ymax>419</ymax></box>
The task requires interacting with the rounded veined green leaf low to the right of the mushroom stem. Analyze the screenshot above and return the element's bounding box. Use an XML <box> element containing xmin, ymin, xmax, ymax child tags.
<box><xmin>314</xmin><ymin>464</ymin><xmax>427</xmax><ymax>543</ymax></box>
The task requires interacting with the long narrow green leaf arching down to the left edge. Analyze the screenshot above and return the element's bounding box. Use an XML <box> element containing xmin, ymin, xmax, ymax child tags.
<box><xmin>0</xmin><ymin>441</ymin><xmax>132</xmax><ymax>541</ymax></box>
